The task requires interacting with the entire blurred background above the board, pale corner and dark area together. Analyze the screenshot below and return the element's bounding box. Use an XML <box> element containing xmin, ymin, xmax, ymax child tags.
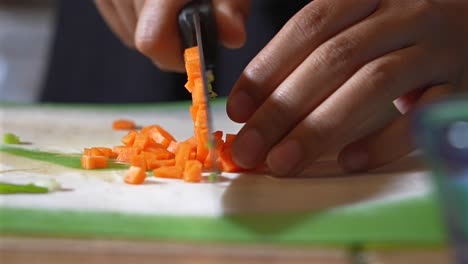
<box><xmin>0</xmin><ymin>0</ymin><xmax>309</xmax><ymax>103</ymax></box>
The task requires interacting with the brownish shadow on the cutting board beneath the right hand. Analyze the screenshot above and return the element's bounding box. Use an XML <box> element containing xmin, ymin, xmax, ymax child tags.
<box><xmin>222</xmin><ymin>157</ymin><xmax>427</xmax><ymax>236</ymax></box>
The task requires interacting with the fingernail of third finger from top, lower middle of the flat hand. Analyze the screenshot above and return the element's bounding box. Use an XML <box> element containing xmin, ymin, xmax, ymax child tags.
<box><xmin>267</xmin><ymin>140</ymin><xmax>304</xmax><ymax>176</ymax></box>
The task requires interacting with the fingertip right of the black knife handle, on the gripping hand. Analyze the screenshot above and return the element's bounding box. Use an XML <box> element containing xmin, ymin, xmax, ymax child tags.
<box><xmin>213</xmin><ymin>0</ymin><xmax>250</xmax><ymax>48</ymax></box>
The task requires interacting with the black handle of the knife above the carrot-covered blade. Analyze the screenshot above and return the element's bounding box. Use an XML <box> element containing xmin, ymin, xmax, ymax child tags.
<box><xmin>178</xmin><ymin>0</ymin><xmax>218</xmax><ymax>70</ymax></box>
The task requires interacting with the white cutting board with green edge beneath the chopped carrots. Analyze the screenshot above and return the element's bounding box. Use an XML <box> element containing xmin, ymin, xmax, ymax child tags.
<box><xmin>0</xmin><ymin>101</ymin><xmax>445</xmax><ymax>247</ymax></box>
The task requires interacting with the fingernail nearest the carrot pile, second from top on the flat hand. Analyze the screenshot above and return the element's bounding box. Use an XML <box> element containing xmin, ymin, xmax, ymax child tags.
<box><xmin>232</xmin><ymin>129</ymin><xmax>265</xmax><ymax>169</ymax></box>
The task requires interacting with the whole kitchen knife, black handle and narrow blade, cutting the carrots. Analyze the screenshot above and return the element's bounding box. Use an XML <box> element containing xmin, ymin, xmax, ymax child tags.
<box><xmin>178</xmin><ymin>0</ymin><xmax>219</xmax><ymax>177</ymax></box>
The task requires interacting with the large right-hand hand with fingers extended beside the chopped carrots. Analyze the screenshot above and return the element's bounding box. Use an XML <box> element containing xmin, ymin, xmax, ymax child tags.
<box><xmin>227</xmin><ymin>0</ymin><xmax>468</xmax><ymax>176</ymax></box>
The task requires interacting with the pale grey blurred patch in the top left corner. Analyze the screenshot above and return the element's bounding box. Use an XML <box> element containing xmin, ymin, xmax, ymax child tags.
<box><xmin>0</xmin><ymin>0</ymin><xmax>54</xmax><ymax>102</ymax></box>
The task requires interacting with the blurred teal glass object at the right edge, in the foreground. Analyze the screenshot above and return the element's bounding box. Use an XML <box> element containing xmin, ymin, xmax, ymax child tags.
<box><xmin>414</xmin><ymin>97</ymin><xmax>468</xmax><ymax>264</ymax></box>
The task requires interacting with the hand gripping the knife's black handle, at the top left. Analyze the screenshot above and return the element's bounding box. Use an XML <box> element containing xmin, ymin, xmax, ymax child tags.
<box><xmin>95</xmin><ymin>0</ymin><xmax>250</xmax><ymax>72</ymax></box>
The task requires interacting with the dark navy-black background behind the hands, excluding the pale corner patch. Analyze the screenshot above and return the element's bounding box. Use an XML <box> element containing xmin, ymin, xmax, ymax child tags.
<box><xmin>41</xmin><ymin>0</ymin><xmax>309</xmax><ymax>103</ymax></box>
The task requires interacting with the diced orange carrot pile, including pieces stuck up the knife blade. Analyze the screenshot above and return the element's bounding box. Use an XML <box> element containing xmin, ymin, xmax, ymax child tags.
<box><xmin>81</xmin><ymin>47</ymin><xmax>241</xmax><ymax>184</ymax></box>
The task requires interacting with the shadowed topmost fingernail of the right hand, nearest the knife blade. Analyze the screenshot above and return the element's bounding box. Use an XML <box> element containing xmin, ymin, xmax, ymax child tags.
<box><xmin>227</xmin><ymin>91</ymin><xmax>255</xmax><ymax>122</ymax></box>
